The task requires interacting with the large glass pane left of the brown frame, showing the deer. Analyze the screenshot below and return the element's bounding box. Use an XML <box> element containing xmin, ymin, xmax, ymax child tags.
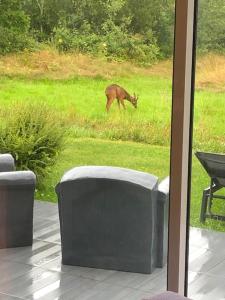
<box><xmin>0</xmin><ymin>0</ymin><xmax>174</xmax><ymax>300</ymax></box>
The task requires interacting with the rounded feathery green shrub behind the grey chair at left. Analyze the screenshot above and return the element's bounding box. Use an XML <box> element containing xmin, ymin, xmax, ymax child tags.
<box><xmin>0</xmin><ymin>104</ymin><xmax>65</xmax><ymax>184</ymax></box>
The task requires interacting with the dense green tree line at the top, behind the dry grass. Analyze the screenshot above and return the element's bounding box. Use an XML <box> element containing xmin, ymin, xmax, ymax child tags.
<box><xmin>0</xmin><ymin>0</ymin><xmax>225</xmax><ymax>64</ymax></box>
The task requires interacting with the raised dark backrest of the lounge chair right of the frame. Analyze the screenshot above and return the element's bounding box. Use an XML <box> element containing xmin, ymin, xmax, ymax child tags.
<box><xmin>195</xmin><ymin>152</ymin><xmax>225</xmax><ymax>187</ymax></box>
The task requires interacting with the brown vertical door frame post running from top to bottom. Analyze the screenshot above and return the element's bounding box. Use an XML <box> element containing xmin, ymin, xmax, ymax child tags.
<box><xmin>167</xmin><ymin>0</ymin><xmax>197</xmax><ymax>295</ymax></box>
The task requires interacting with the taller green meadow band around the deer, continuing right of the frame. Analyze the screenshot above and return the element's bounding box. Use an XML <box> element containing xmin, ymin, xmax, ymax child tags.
<box><xmin>0</xmin><ymin>76</ymin><xmax>225</xmax><ymax>152</ymax></box>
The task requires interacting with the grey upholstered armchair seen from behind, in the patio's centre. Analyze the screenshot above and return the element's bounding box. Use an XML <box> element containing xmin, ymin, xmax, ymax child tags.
<box><xmin>56</xmin><ymin>166</ymin><xmax>168</xmax><ymax>273</ymax></box>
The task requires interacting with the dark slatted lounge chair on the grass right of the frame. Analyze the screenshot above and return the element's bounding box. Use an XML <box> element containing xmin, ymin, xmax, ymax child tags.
<box><xmin>195</xmin><ymin>152</ymin><xmax>225</xmax><ymax>223</ymax></box>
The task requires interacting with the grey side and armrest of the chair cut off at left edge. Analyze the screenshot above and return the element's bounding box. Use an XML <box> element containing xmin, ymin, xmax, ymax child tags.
<box><xmin>0</xmin><ymin>171</ymin><xmax>36</xmax><ymax>248</ymax></box>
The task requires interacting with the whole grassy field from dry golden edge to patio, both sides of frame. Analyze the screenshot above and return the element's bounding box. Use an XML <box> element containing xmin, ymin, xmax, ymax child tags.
<box><xmin>0</xmin><ymin>50</ymin><xmax>225</xmax><ymax>231</ymax></box>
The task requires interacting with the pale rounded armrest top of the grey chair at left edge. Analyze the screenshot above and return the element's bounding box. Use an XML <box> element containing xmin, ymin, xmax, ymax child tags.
<box><xmin>0</xmin><ymin>171</ymin><xmax>36</xmax><ymax>186</ymax></box>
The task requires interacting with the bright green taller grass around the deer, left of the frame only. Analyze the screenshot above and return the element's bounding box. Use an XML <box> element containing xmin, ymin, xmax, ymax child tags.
<box><xmin>0</xmin><ymin>76</ymin><xmax>171</xmax><ymax>145</ymax></box>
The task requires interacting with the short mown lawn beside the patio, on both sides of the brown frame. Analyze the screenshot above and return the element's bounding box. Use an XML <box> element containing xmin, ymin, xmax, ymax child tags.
<box><xmin>37</xmin><ymin>138</ymin><xmax>225</xmax><ymax>231</ymax></box>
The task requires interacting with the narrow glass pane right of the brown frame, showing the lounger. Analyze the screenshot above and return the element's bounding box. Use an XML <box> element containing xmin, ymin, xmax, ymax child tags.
<box><xmin>189</xmin><ymin>0</ymin><xmax>225</xmax><ymax>300</ymax></box>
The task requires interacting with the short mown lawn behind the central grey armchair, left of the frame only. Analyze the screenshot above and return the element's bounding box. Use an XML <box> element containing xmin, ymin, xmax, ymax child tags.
<box><xmin>37</xmin><ymin>138</ymin><xmax>169</xmax><ymax>201</ymax></box>
